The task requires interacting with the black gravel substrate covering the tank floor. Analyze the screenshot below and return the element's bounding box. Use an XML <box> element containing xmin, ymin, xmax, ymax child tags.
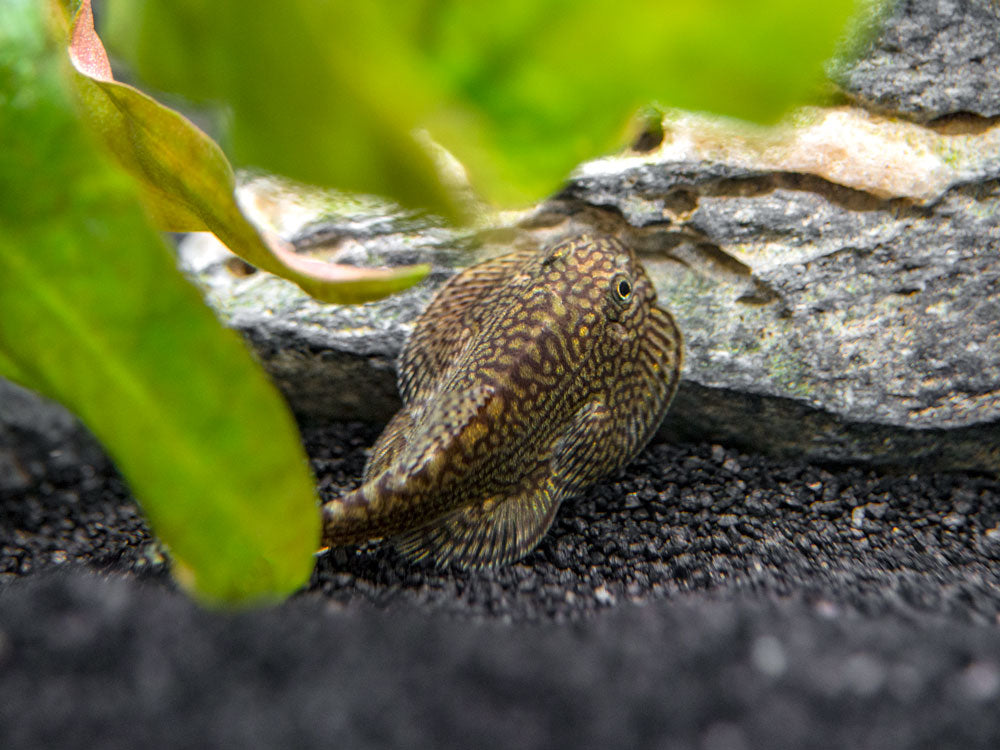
<box><xmin>0</xmin><ymin>425</ymin><xmax>1000</xmax><ymax>750</ymax></box>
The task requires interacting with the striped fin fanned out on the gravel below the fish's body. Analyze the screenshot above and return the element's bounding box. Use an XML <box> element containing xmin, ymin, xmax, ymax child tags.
<box><xmin>394</xmin><ymin>478</ymin><xmax>563</xmax><ymax>568</ymax></box>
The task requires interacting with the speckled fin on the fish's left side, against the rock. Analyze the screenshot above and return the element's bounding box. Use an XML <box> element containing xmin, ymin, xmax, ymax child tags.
<box><xmin>399</xmin><ymin>249</ymin><xmax>538</xmax><ymax>404</ymax></box>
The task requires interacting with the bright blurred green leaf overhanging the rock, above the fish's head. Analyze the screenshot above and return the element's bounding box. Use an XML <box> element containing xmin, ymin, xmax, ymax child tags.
<box><xmin>422</xmin><ymin>0</ymin><xmax>855</xmax><ymax>206</ymax></box>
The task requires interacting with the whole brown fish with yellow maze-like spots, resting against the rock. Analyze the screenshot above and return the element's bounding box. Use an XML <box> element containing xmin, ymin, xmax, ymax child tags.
<box><xmin>323</xmin><ymin>235</ymin><xmax>682</xmax><ymax>567</ymax></box>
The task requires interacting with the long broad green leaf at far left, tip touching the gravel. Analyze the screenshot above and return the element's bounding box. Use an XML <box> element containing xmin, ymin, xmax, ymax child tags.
<box><xmin>0</xmin><ymin>0</ymin><xmax>319</xmax><ymax>601</ymax></box>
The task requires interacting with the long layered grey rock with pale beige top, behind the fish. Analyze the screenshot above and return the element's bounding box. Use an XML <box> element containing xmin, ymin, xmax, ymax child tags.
<box><xmin>181</xmin><ymin>110</ymin><xmax>1000</xmax><ymax>472</ymax></box>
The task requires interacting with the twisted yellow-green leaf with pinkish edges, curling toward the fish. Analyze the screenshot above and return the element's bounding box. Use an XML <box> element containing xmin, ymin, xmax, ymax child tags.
<box><xmin>59</xmin><ymin>0</ymin><xmax>430</xmax><ymax>304</ymax></box>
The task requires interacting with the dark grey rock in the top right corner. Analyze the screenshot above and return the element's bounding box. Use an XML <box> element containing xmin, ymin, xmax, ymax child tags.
<box><xmin>833</xmin><ymin>0</ymin><xmax>1000</xmax><ymax>120</ymax></box>
